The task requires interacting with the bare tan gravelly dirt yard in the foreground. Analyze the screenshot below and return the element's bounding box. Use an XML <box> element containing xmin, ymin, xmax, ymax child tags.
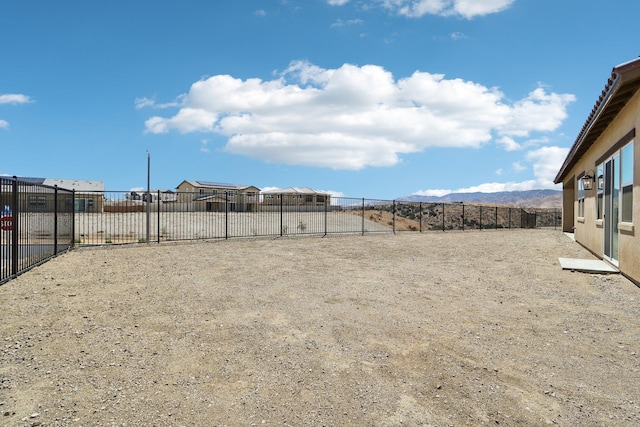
<box><xmin>0</xmin><ymin>230</ymin><xmax>640</xmax><ymax>426</ymax></box>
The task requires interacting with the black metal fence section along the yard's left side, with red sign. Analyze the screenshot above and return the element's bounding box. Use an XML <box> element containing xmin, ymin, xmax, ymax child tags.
<box><xmin>0</xmin><ymin>177</ymin><xmax>74</xmax><ymax>284</ymax></box>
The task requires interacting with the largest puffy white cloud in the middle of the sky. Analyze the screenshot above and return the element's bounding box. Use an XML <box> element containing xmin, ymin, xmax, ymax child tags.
<box><xmin>139</xmin><ymin>61</ymin><xmax>574</xmax><ymax>170</ymax></box>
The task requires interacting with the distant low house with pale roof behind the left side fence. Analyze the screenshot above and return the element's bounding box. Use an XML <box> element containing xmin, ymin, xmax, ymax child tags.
<box><xmin>0</xmin><ymin>177</ymin><xmax>104</xmax><ymax>212</ymax></box>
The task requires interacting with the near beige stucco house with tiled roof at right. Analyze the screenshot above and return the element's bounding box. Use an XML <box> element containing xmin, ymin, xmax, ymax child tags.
<box><xmin>554</xmin><ymin>58</ymin><xmax>640</xmax><ymax>285</ymax></box>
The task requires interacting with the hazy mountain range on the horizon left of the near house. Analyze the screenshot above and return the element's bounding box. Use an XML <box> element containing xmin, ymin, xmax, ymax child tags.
<box><xmin>396</xmin><ymin>190</ymin><xmax>562</xmax><ymax>209</ymax></box>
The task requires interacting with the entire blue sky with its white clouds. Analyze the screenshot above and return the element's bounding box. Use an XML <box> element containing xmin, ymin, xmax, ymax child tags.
<box><xmin>0</xmin><ymin>0</ymin><xmax>640</xmax><ymax>199</ymax></box>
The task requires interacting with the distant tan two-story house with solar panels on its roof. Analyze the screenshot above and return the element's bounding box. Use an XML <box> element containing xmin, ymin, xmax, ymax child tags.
<box><xmin>176</xmin><ymin>180</ymin><xmax>260</xmax><ymax>212</ymax></box>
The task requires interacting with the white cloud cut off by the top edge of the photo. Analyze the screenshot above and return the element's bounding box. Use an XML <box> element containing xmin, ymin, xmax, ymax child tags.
<box><xmin>327</xmin><ymin>0</ymin><xmax>515</xmax><ymax>19</ymax></box>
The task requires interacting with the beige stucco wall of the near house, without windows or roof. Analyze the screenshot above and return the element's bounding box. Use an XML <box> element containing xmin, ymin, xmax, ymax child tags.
<box><xmin>563</xmin><ymin>92</ymin><xmax>640</xmax><ymax>282</ymax></box>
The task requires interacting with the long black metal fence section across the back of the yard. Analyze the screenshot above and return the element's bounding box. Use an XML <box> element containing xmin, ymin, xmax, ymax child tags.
<box><xmin>74</xmin><ymin>191</ymin><xmax>561</xmax><ymax>245</ymax></box>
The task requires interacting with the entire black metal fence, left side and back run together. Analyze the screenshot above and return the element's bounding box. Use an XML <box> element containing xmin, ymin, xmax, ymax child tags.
<box><xmin>0</xmin><ymin>186</ymin><xmax>561</xmax><ymax>284</ymax></box>
